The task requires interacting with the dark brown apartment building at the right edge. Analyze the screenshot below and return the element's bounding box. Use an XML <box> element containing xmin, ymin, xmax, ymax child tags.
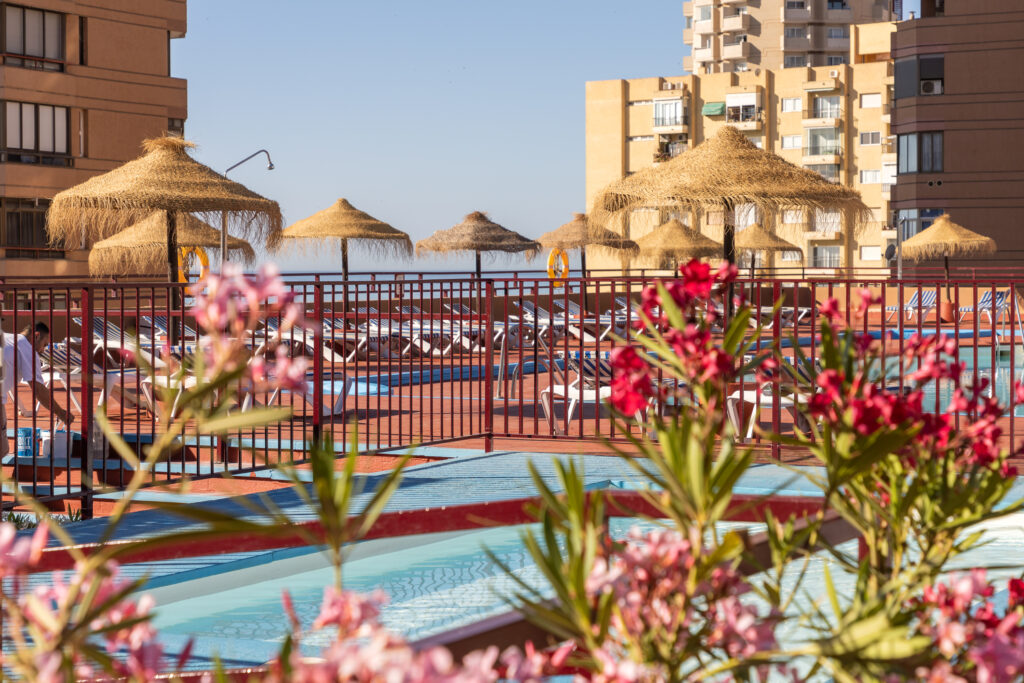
<box><xmin>892</xmin><ymin>0</ymin><xmax>1024</xmax><ymax>265</ymax></box>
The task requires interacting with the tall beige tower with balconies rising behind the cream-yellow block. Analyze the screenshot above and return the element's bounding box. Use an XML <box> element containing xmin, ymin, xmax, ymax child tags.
<box><xmin>683</xmin><ymin>0</ymin><xmax>899</xmax><ymax>76</ymax></box>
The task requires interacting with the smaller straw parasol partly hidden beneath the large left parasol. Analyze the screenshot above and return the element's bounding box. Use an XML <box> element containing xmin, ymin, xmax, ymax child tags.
<box><xmin>89</xmin><ymin>211</ymin><xmax>256</xmax><ymax>275</ymax></box>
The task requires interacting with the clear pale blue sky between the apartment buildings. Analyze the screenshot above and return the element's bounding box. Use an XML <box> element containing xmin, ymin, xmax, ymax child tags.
<box><xmin>171</xmin><ymin>0</ymin><xmax>918</xmax><ymax>270</ymax></box>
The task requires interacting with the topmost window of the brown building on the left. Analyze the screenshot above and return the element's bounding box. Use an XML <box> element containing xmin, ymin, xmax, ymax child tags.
<box><xmin>2</xmin><ymin>5</ymin><xmax>63</xmax><ymax>71</ymax></box>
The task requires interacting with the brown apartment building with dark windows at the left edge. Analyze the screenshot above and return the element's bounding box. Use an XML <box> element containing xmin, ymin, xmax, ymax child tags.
<box><xmin>0</xmin><ymin>0</ymin><xmax>187</xmax><ymax>276</ymax></box>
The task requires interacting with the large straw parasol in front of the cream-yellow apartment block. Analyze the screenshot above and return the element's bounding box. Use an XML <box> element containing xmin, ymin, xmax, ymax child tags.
<box><xmin>592</xmin><ymin>126</ymin><xmax>870</xmax><ymax>261</ymax></box>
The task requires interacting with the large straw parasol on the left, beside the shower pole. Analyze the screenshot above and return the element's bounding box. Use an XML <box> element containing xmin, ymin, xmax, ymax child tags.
<box><xmin>46</xmin><ymin>137</ymin><xmax>282</xmax><ymax>282</ymax></box>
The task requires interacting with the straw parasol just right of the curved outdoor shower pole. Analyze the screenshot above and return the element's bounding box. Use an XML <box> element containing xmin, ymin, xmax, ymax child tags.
<box><xmin>281</xmin><ymin>199</ymin><xmax>413</xmax><ymax>280</ymax></box>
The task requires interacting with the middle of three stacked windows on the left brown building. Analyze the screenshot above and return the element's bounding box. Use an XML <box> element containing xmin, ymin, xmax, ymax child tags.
<box><xmin>0</xmin><ymin>102</ymin><xmax>71</xmax><ymax>166</ymax></box>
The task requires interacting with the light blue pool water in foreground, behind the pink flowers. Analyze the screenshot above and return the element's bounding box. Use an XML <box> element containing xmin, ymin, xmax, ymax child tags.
<box><xmin>146</xmin><ymin>514</ymin><xmax>1024</xmax><ymax>669</ymax></box>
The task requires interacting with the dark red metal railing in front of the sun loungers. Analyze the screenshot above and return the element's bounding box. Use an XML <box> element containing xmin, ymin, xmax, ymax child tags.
<box><xmin>0</xmin><ymin>275</ymin><xmax>1022</xmax><ymax>515</ymax></box>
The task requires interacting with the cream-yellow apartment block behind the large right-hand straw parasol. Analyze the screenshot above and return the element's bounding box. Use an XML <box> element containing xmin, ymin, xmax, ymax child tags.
<box><xmin>586</xmin><ymin>23</ymin><xmax>897</xmax><ymax>268</ymax></box>
